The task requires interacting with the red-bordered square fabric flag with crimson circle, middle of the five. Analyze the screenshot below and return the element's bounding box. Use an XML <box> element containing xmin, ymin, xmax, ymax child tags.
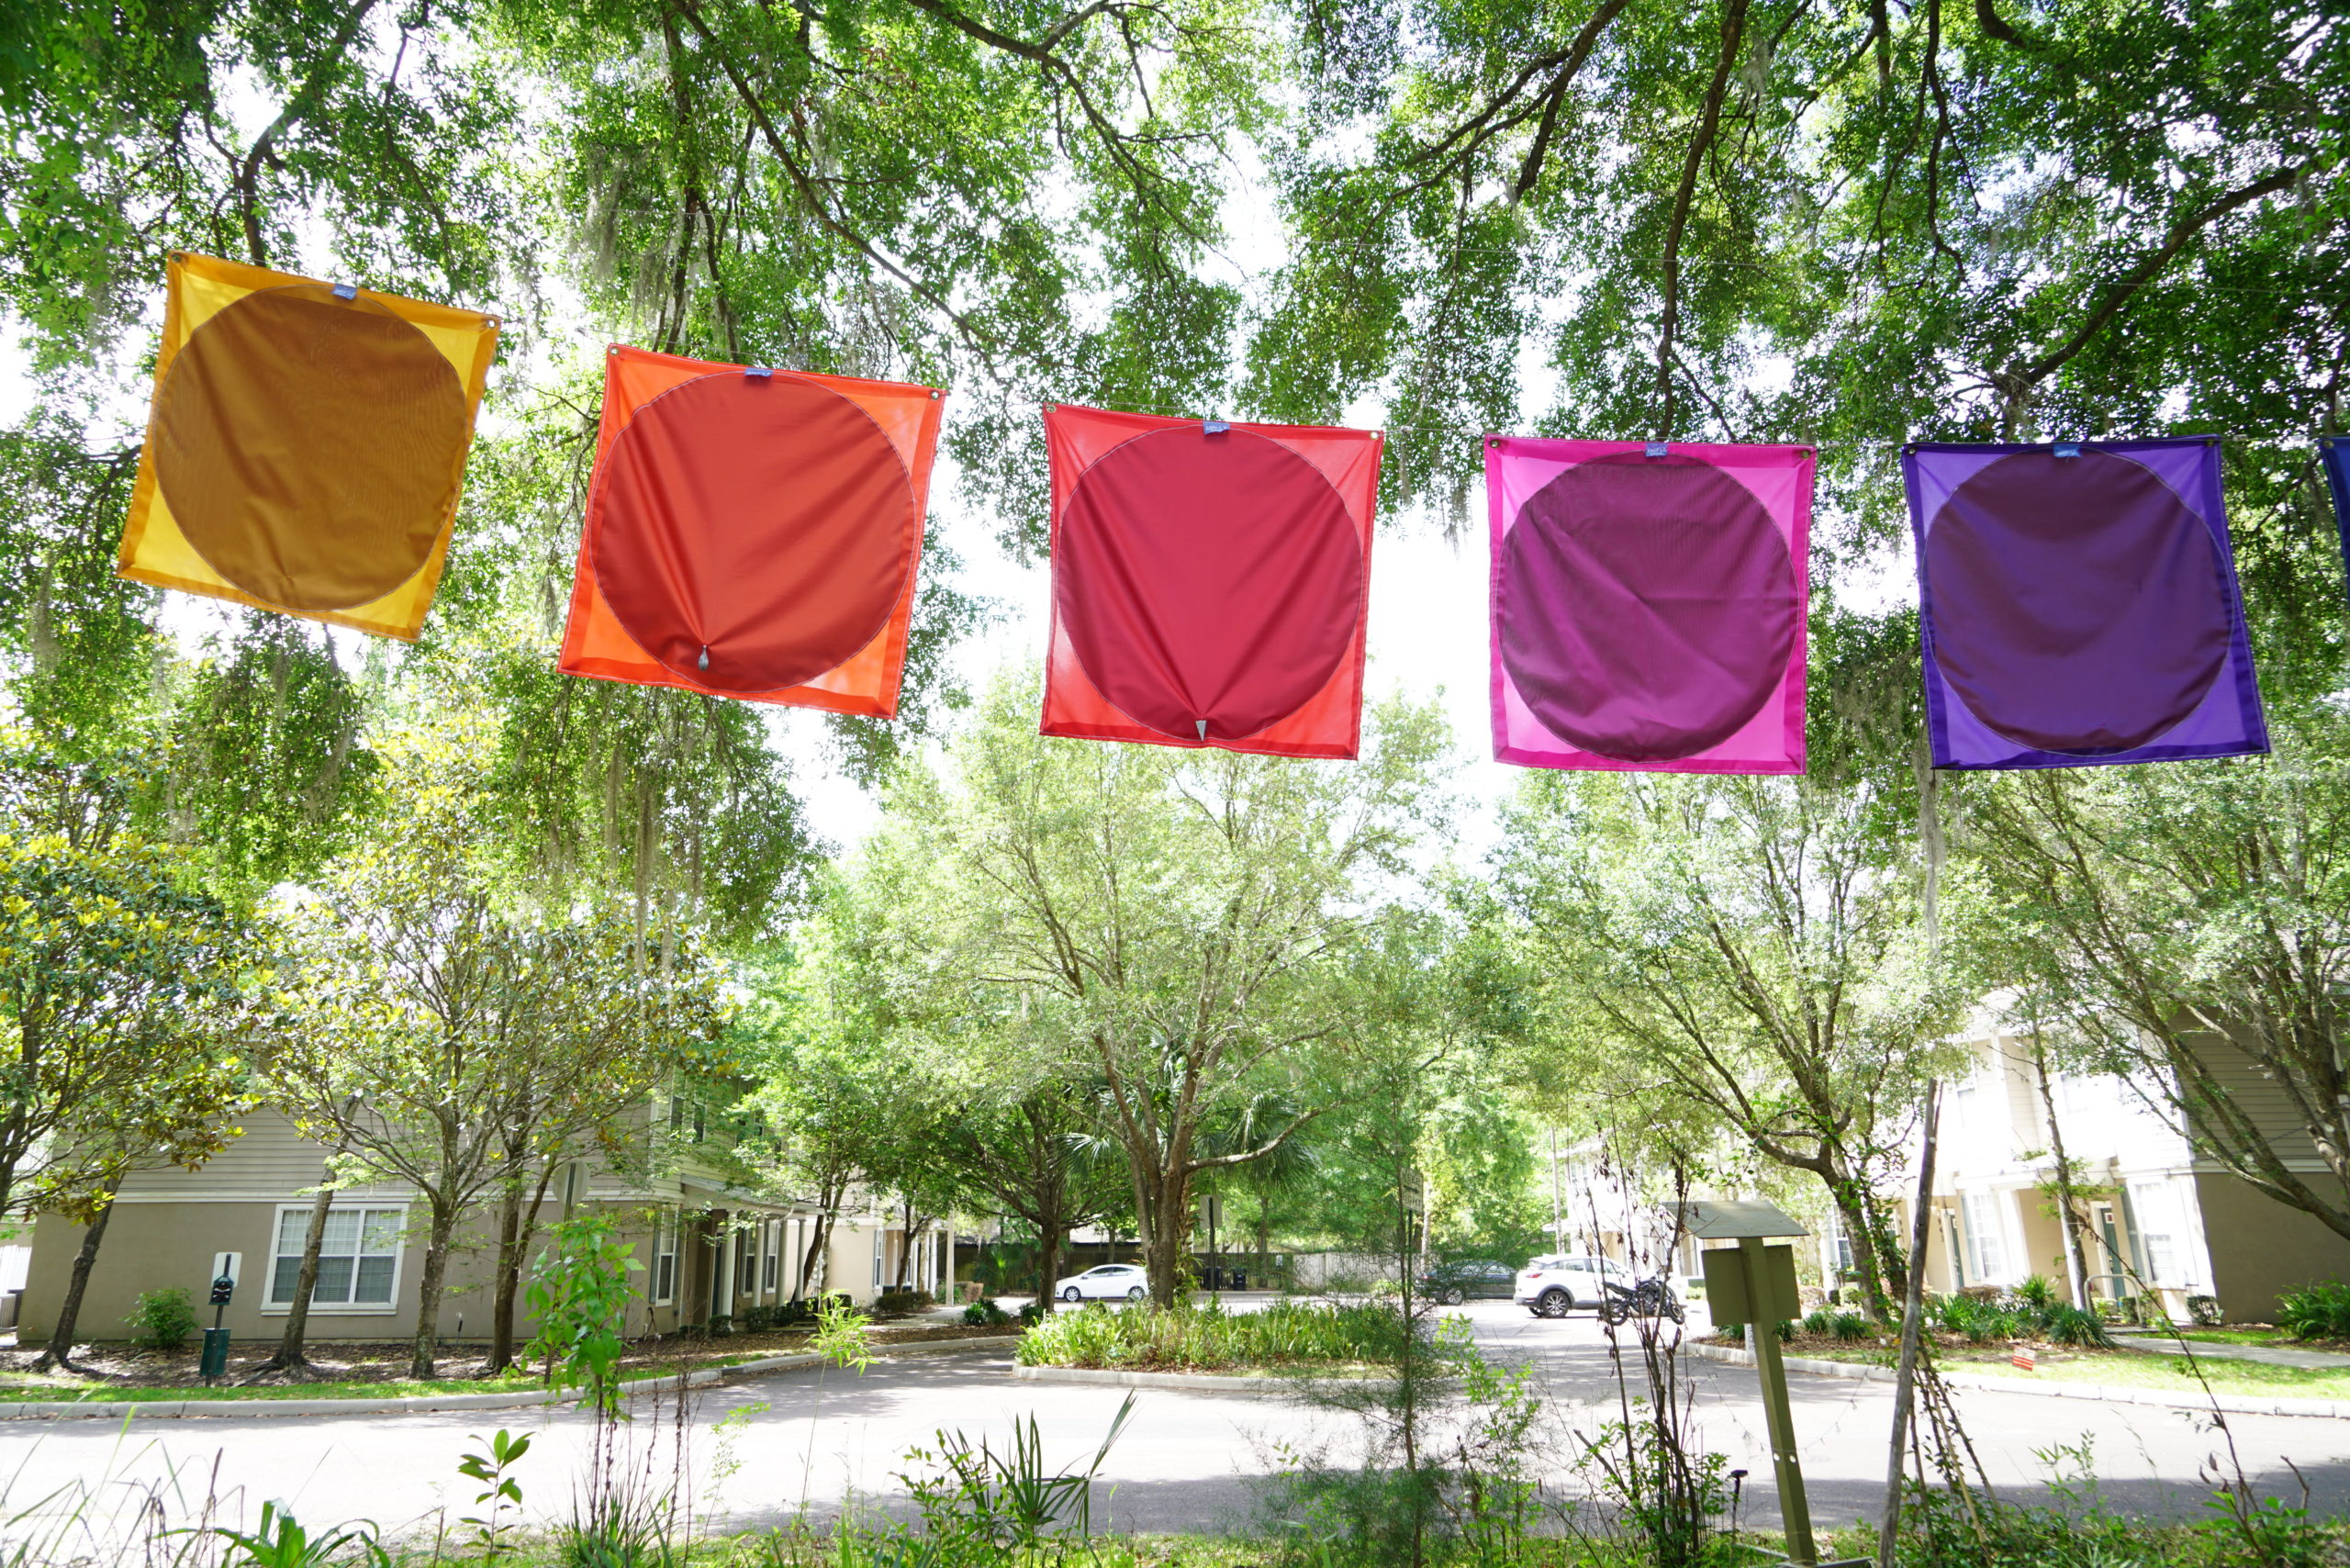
<box><xmin>1039</xmin><ymin>404</ymin><xmax>1382</xmax><ymax>757</ymax></box>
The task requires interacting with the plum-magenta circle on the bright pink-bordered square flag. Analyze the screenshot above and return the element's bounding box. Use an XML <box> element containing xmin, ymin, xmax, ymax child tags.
<box><xmin>1494</xmin><ymin>454</ymin><xmax>1797</xmax><ymax>762</ymax></box>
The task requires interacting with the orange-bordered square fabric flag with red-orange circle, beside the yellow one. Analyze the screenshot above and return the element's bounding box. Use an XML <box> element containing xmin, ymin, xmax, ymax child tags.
<box><xmin>559</xmin><ymin>343</ymin><xmax>943</xmax><ymax>720</ymax></box>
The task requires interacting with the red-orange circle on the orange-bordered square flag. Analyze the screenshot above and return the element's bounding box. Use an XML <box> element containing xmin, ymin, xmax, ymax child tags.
<box><xmin>588</xmin><ymin>372</ymin><xmax>922</xmax><ymax>696</ymax></box>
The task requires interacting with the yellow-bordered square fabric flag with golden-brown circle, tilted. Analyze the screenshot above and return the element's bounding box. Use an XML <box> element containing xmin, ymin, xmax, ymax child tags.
<box><xmin>118</xmin><ymin>254</ymin><xmax>498</xmax><ymax>640</ymax></box>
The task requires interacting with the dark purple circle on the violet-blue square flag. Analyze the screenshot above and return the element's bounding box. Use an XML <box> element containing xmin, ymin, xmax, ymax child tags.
<box><xmin>1925</xmin><ymin>452</ymin><xmax>2235</xmax><ymax>755</ymax></box>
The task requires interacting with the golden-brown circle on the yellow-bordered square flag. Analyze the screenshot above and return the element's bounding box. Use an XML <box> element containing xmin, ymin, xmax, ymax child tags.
<box><xmin>155</xmin><ymin>285</ymin><xmax>470</xmax><ymax>611</ymax></box>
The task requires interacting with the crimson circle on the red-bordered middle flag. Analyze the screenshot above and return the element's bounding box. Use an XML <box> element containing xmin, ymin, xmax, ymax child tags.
<box><xmin>1053</xmin><ymin>425</ymin><xmax>1363</xmax><ymax>743</ymax></box>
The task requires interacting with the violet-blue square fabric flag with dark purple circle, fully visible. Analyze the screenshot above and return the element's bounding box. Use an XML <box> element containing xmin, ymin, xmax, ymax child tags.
<box><xmin>1901</xmin><ymin>435</ymin><xmax>2267</xmax><ymax>768</ymax></box>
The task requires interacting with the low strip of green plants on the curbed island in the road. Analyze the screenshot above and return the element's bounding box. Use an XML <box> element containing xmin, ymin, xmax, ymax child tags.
<box><xmin>1017</xmin><ymin>1300</ymin><xmax>1427</xmax><ymax>1368</ymax></box>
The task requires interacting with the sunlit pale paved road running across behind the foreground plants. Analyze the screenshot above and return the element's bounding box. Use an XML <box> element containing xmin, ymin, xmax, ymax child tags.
<box><xmin>0</xmin><ymin>1303</ymin><xmax>2350</xmax><ymax>1530</ymax></box>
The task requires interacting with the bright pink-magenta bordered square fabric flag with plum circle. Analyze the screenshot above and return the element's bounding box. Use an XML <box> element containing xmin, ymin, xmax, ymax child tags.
<box><xmin>1485</xmin><ymin>435</ymin><xmax>1817</xmax><ymax>773</ymax></box>
